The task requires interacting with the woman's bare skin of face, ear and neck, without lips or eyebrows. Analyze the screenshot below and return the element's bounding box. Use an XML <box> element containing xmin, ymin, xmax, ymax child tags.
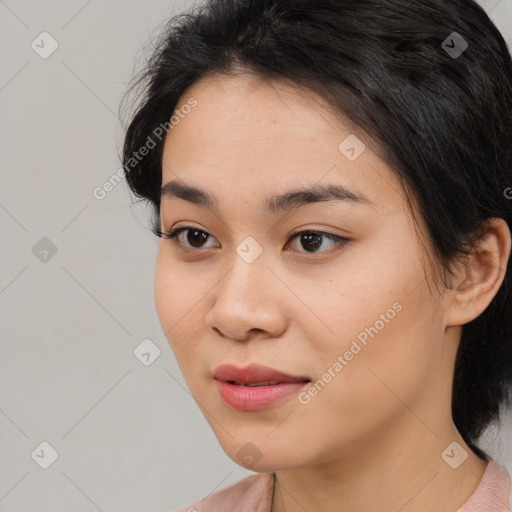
<box><xmin>155</xmin><ymin>75</ymin><xmax>511</xmax><ymax>512</ymax></box>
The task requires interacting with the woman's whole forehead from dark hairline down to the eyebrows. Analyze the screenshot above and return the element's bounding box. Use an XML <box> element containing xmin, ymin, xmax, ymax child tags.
<box><xmin>162</xmin><ymin>75</ymin><xmax>402</xmax><ymax>214</ymax></box>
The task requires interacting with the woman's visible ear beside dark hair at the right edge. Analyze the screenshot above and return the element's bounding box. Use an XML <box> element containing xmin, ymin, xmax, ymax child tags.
<box><xmin>446</xmin><ymin>218</ymin><xmax>511</xmax><ymax>327</ymax></box>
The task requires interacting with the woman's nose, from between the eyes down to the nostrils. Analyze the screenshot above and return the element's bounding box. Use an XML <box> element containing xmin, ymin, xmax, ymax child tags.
<box><xmin>205</xmin><ymin>246</ymin><xmax>289</xmax><ymax>341</ymax></box>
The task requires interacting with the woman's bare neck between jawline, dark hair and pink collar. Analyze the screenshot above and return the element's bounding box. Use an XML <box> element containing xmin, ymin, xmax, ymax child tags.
<box><xmin>271</xmin><ymin>328</ymin><xmax>487</xmax><ymax>512</ymax></box>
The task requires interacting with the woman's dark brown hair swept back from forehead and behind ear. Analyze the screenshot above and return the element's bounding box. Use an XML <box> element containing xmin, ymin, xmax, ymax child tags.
<box><xmin>122</xmin><ymin>0</ymin><xmax>512</xmax><ymax>457</ymax></box>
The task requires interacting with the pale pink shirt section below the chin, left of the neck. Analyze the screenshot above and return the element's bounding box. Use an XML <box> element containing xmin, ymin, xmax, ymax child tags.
<box><xmin>175</xmin><ymin>473</ymin><xmax>274</xmax><ymax>512</ymax></box>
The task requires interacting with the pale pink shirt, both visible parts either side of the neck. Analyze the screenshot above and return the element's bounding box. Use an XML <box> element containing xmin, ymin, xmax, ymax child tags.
<box><xmin>176</xmin><ymin>459</ymin><xmax>512</xmax><ymax>512</ymax></box>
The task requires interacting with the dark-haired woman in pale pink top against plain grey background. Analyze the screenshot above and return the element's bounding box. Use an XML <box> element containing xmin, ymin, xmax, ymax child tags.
<box><xmin>123</xmin><ymin>0</ymin><xmax>512</xmax><ymax>512</ymax></box>
